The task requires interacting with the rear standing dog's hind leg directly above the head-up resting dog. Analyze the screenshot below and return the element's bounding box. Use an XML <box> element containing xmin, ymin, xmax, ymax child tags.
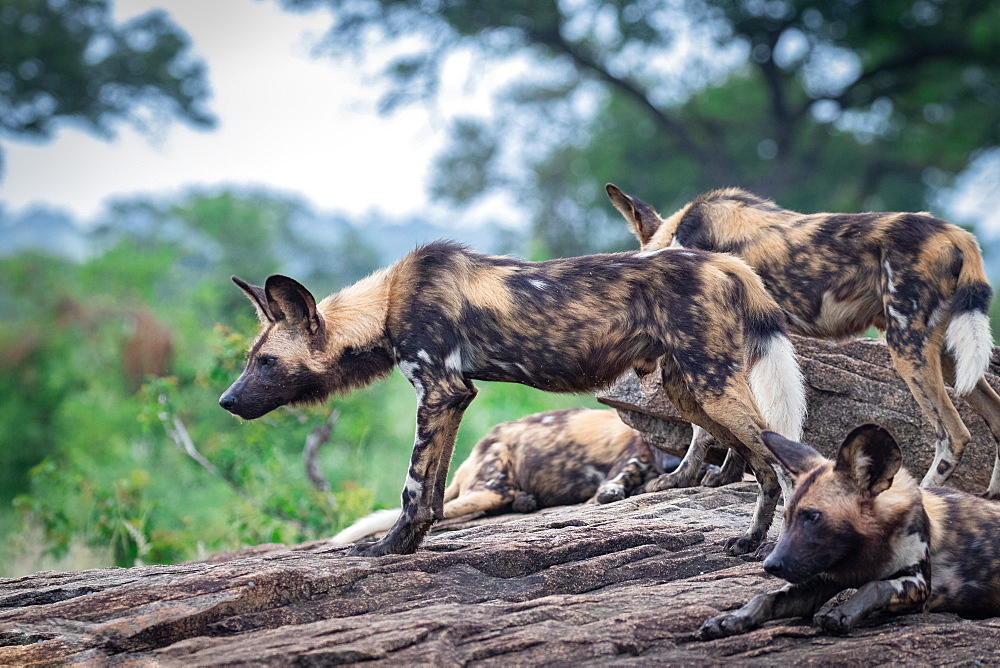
<box><xmin>885</xmin><ymin>298</ymin><xmax>972</xmax><ymax>487</ymax></box>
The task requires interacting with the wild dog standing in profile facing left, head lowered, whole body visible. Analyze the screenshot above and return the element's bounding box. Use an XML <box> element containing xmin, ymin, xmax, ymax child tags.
<box><xmin>219</xmin><ymin>242</ymin><xmax>805</xmax><ymax>556</ymax></box>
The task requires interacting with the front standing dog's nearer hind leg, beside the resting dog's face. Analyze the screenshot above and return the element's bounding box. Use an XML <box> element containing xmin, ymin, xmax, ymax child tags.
<box><xmin>662</xmin><ymin>358</ymin><xmax>781</xmax><ymax>556</ymax></box>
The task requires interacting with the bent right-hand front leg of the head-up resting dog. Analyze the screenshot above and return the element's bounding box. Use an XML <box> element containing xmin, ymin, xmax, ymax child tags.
<box><xmin>813</xmin><ymin>566</ymin><xmax>930</xmax><ymax>634</ymax></box>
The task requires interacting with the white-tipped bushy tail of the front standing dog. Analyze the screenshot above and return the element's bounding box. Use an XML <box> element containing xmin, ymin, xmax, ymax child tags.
<box><xmin>739</xmin><ymin>267</ymin><xmax>806</xmax><ymax>440</ymax></box>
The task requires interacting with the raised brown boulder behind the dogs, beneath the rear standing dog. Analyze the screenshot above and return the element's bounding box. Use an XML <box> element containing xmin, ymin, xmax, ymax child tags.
<box><xmin>597</xmin><ymin>336</ymin><xmax>1000</xmax><ymax>493</ymax></box>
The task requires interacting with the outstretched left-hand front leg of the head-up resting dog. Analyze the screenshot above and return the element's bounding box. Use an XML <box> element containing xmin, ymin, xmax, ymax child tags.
<box><xmin>698</xmin><ymin>578</ymin><xmax>840</xmax><ymax>640</ymax></box>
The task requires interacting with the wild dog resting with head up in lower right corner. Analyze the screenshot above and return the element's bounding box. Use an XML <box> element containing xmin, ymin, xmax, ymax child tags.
<box><xmin>699</xmin><ymin>424</ymin><xmax>1000</xmax><ymax>639</ymax></box>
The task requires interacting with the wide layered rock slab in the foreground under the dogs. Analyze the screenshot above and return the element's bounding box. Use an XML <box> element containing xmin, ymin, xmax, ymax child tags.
<box><xmin>0</xmin><ymin>483</ymin><xmax>1000</xmax><ymax>666</ymax></box>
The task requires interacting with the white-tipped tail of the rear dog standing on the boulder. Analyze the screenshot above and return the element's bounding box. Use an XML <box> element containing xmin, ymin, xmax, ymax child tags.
<box><xmin>944</xmin><ymin>228</ymin><xmax>993</xmax><ymax>394</ymax></box>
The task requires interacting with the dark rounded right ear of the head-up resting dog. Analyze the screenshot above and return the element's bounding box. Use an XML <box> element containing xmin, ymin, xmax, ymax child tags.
<box><xmin>834</xmin><ymin>424</ymin><xmax>903</xmax><ymax>496</ymax></box>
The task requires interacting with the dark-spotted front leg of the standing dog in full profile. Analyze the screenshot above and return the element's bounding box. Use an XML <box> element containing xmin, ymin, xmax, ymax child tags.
<box><xmin>348</xmin><ymin>374</ymin><xmax>476</xmax><ymax>557</ymax></box>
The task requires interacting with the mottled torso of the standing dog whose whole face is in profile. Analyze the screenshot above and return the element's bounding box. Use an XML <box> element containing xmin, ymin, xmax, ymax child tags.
<box><xmin>389</xmin><ymin>242</ymin><xmax>768</xmax><ymax>392</ymax></box>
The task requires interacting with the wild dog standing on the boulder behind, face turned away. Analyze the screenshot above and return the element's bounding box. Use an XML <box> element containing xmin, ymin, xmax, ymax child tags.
<box><xmin>607</xmin><ymin>184</ymin><xmax>1000</xmax><ymax>498</ymax></box>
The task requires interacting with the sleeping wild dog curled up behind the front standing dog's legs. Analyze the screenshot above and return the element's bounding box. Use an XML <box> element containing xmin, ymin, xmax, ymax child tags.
<box><xmin>330</xmin><ymin>408</ymin><xmax>680</xmax><ymax>545</ymax></box>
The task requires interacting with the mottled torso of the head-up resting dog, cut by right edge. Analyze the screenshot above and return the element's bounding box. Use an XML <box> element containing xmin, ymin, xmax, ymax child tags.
<box><xmin>921</xmin><ymin>488</ymin><xmax>1000</xmax><ymax>617</ymax></box>
